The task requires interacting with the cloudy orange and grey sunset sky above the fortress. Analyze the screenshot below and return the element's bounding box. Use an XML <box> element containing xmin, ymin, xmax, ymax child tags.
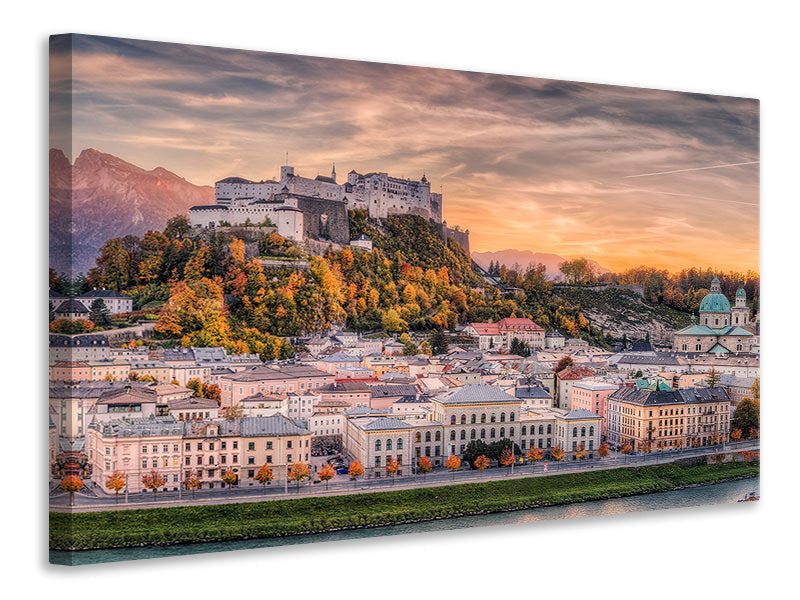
<box><xmin>51</xmin><ymin>36</ymin><xmax>759</xmax><ymax>271</ymax></box>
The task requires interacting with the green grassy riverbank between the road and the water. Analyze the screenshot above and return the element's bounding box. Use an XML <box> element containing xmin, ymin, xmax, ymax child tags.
<box><xmin>50</xmin><ymin>462</ymin><xmax>759</xmax><ymax>550</ymax></box>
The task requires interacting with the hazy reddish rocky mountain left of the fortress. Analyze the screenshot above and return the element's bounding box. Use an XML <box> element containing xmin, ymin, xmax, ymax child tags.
<box><xmin>50</xmin><ymin>148</ymin><xmax>214</xmax><ymax>276</ymax></box>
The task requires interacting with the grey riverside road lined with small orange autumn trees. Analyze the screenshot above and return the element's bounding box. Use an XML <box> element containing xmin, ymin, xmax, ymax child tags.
<box><xmin>50</xmin><ymin>440</ymin><xmax>759</xmax><ymax>512</ymax></box>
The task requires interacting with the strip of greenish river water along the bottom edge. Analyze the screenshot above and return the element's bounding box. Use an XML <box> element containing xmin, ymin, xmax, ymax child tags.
<box><xmin>50</xmin><ymin>477</ymin><xmax>760</xmax><ymax>565</ymax></box>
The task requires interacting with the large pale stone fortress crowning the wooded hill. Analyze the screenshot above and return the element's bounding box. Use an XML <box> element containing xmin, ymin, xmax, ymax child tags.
<box><xmin>189</xmin><ymin>165</ymin><xmax>469</xmax><ymax>251</ymax></box>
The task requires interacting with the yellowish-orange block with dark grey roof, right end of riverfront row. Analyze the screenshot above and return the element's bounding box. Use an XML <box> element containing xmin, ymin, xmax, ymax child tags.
<box><xmin>607</xmin><ymin>387</ymin><xmax>731</xmax><ymax>450</ymax></box>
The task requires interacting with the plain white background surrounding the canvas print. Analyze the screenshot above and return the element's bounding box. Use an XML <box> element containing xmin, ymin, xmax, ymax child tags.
<box><xmin>0</xmin><ymin>1</ymin><xmax>800</xmax><ymax>600</ymax></box>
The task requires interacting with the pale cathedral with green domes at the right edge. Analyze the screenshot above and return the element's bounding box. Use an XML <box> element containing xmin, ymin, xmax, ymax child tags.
<box><xmin>672</xmin><ymin>277</ymin><xmax>756</xmax><ymax>354</ymax></box>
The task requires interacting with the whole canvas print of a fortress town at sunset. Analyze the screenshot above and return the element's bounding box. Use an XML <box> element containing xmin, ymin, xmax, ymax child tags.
<box><xmin>48</xmin><ymin>34</ymin><xmax>761</xmax><ymax>565</ymax></box>
